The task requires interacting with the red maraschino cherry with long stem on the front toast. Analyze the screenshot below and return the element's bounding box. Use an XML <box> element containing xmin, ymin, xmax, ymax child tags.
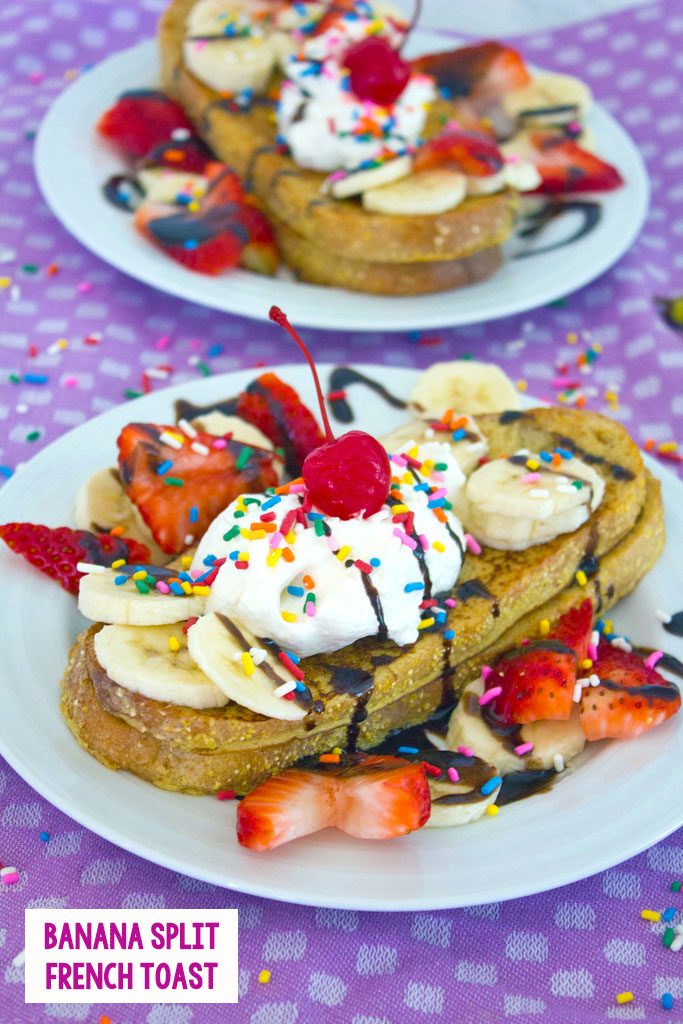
<box><xmin>268</xmin><ymin>306</ymin><xmax>391</xmax><ymax>519</ymax></box>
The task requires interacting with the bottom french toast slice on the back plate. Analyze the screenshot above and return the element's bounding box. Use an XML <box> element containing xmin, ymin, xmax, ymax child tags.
<box><xmin>272</xmin><ymin>218</ymin><xmax>503</xmax><ymax>295</ymax></box>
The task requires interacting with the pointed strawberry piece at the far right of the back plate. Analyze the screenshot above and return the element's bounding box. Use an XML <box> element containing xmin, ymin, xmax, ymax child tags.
<box><xmin>524</xmin><ymin>131</ymin><xmax>624</xmax><ymax>194</ymax></box>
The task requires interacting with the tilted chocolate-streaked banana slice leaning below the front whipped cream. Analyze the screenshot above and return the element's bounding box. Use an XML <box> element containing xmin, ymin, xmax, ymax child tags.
<box><xmin>187</xmin><ymin>611</ymin><xmax>306</xmax><ymax>722</ymax></box>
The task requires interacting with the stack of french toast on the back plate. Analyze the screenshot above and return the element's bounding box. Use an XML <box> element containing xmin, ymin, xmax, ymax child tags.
<box><xmin>159</xmin><ymin>0</ymin><xmax>540</xmax><ymax>295</ymax></box>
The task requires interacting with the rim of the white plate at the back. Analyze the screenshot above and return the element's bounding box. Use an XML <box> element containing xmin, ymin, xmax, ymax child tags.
<box><xmin>34</xmin><ymin>30</ymin><xmax>651</xmax><ymax>332</ymax></box>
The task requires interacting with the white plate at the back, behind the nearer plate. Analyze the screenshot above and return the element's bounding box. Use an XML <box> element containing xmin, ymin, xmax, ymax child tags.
<box><xmin>36</xmin><ymin>32</ymin><xmax>649</xmax><ymax>331</ymax></box>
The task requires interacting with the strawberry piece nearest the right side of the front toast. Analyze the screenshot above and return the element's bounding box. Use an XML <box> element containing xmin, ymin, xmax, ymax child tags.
<box><xmin>484</xmin><ymin>600</ymin><xmax>593</xmax><ymax>726</ymax></box>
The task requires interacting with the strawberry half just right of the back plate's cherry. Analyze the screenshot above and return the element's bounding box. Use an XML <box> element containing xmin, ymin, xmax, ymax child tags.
<box><xmin>412</xmin><ymin>40</ymin><xmax>531</xmax><ymax>108</ymax></box>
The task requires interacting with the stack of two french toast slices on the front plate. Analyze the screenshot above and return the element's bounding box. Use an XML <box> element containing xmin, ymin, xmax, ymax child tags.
<box><xmin>61</xmin><ymin>409</ymin><xmax>664</xmax><ymax>794</ymax></box>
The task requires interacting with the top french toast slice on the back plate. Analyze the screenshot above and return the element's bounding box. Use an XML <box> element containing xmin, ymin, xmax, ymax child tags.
<box><xmin>159</xmin><ymin>0</ymin><xmax>517</xmax><ymax>268</ymax></box>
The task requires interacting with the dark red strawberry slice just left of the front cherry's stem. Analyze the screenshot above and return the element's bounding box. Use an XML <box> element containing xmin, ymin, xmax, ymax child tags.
<box><xmin>237</xmin><ymin>374</ymin><xmax>325</xmax><ymax>476</ymax></box>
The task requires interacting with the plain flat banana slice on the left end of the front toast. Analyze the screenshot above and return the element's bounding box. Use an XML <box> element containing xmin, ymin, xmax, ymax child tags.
<box><xmin>95</xmin><ymin>625</ymin><xmax>227</xmax><ymax>710</ymax></box>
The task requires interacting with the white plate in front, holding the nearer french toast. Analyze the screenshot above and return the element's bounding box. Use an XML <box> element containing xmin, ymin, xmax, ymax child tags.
<box><xmin>0</xmin><ymin>366</ymin><xmax>683</xmax><ymax>910</ymax></box>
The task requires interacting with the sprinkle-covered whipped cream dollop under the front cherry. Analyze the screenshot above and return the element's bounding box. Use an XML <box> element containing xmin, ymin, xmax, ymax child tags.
<box><xmin>193</xmin><ymin>441</ymin><xmax>465</xmax><ymax>656</ymax></box>
